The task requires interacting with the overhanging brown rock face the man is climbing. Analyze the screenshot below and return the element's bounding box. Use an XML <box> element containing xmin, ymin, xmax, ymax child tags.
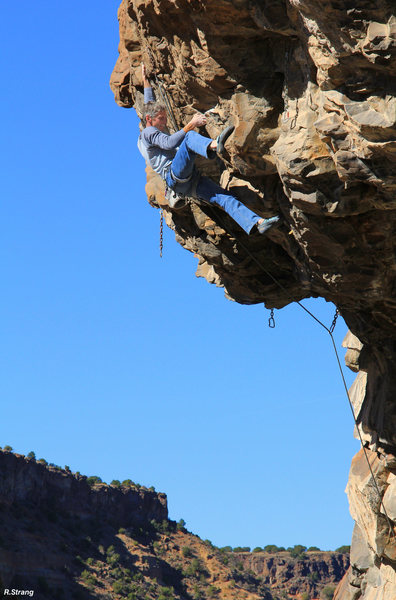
<box><xmin>111</xmin><ymin>0</ymin><xmax>396</xmax><ymax>600</ymax></box>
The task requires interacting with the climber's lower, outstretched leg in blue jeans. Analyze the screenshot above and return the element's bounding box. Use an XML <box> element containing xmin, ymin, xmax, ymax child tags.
<box><xmin>196</xmin><ymin>177</ymin><xmax>263</xmax><ymax>233</ymax></box>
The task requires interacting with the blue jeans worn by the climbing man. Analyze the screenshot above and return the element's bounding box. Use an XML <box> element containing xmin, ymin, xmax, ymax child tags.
<box><xmin>166</xmin><ymin>131</ymin><xmax>261</xmax><ymax>233</ymax></box>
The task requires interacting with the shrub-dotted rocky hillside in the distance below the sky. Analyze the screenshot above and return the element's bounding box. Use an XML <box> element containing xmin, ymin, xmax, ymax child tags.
<box><xmin>0</xmin><ymin>451</ymin><xmax>348</xmax><ymax>600</ymax></box>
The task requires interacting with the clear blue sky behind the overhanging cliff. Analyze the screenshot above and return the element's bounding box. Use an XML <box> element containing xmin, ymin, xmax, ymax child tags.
<box><xmin>0</xmin><ymin>0</ymin><xmax>358</xmax><ymax>549</ymax></box>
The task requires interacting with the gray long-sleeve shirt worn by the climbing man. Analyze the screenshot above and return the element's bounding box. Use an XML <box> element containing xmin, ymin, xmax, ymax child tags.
<box><xmin>138</xmin><ymin>87</ymin><xmax>186</xmax><ymax>179</ymax></box>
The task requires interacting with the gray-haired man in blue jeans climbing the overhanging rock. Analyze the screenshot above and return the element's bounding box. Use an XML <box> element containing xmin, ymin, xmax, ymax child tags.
<box><xmin>138</xmin><ymin>64</ymin><xmax>279</xmax><ymax>234</ymax></box>
